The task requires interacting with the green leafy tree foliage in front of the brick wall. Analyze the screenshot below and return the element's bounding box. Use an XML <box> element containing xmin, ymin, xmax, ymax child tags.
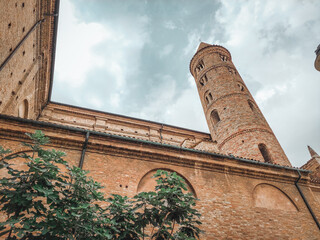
<box><xmin>0</xmin><ymin>131</ymin><xmax>201</xmax><ymax>240</ymax></box>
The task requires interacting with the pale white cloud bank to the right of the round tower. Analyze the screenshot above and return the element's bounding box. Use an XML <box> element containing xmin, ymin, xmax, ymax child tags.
<box><xmin>212</xmin><ymin>0</ymin><xmax>320</xmax><ymax>166</ymax></box>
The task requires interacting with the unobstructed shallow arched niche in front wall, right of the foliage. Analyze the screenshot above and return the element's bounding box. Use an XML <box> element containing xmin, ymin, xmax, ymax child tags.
<box><xmin>253</xmin><ymin>183</ymin><xmax>298</xmax><ymax>211</ymax></box>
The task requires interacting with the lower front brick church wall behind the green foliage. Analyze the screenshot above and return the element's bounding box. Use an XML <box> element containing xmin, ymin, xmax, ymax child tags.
<box><xmin>0</xmin><ymin>119</ymin><xmax>320</xmax><ymax>239</ymax></box>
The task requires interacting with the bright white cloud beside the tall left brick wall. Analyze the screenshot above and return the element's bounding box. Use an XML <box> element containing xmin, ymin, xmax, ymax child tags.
<box><xmin>55</xmin><ymin>0</ymin><xmax>150</xmax><ymax>96</ymax></box>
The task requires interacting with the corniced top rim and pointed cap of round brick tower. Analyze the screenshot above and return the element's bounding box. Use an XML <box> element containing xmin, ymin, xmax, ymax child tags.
<box><xmin>189</xmin><ymin>42</ymin><xmax>231</xmax><ymax>75</ymax></box>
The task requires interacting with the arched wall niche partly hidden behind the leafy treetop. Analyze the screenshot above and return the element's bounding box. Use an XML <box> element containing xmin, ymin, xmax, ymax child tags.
<box><xmin>137</xmin><ymin>168</ymin><xmax>197</xmax><ymax>197</ymax></box>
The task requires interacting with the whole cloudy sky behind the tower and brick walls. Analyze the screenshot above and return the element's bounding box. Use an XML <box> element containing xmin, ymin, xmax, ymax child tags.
<box><xmin>52</xmin><ymin>0</ymin><xmax>320</xmax><ymax>166</ymax></box>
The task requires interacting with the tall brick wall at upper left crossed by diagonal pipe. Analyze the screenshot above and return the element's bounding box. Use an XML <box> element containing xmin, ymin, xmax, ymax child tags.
<box><xmin>0</xmin><ymin>0</ymin><xmax>55</xmax><ymax>119</ymax></box>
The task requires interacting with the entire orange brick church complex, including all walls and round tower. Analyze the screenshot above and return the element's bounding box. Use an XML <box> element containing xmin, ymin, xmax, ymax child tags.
<box><xmin>0</xmin><ymin>0</ymin><xmax>320</xmax><ymax>240</ymax></box>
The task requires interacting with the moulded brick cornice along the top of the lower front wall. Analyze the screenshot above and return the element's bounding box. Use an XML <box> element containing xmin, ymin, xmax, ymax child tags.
<box><xmin>0</xmin><ymin>115</ymin><xmax>309</xmax><ymax>182</ymax></box>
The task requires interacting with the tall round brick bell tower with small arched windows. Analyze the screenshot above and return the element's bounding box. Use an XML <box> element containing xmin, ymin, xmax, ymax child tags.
<box><xmin>190</xmin><ymin>43</ymin><xmax>291</xmax><ymax>166</ymax></box>
